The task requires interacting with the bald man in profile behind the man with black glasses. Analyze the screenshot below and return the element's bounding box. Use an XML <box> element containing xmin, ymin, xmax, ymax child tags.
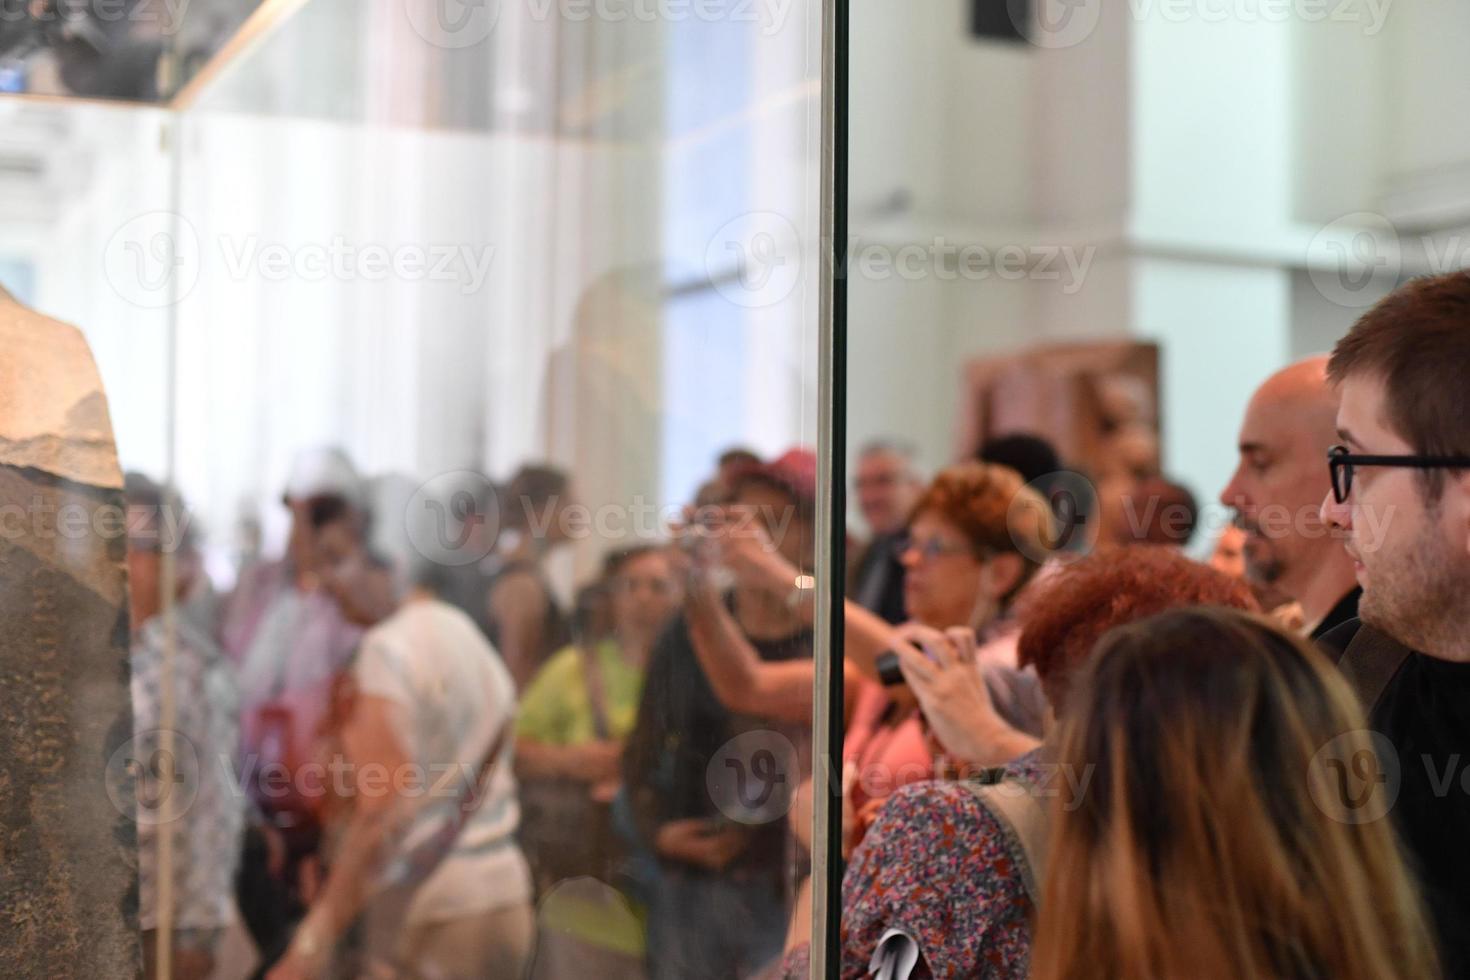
<box><xmin>1220</xmin><ymin>356</ymin><xmax>1361</xmax><ymax>639</ymax></box>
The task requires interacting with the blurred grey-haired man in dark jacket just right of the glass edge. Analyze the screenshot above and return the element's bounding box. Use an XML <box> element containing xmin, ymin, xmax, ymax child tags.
<box><xmin>848</xmin><ymin>439</ymin><xmax>925</xmax><ymax>623</ymax></box>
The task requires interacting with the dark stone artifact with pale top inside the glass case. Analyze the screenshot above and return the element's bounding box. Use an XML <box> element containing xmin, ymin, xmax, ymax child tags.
<box><xmin>0</xmin><ymin>289</ymin><xmax>140</xmax><ymax>980</ymax></box>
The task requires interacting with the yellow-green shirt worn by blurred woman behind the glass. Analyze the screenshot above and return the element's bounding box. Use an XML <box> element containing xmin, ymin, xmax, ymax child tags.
<box><xmin>516</xmin><ymin>639</ymin><xmax>644</xmax><ymax>745</ymax></box>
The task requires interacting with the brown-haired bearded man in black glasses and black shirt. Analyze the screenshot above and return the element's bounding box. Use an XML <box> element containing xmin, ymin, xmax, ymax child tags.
<box><xmin>1322</xmin><ymin>272</ymin><xmax>1470</xmax><ymax>977</ymax></box>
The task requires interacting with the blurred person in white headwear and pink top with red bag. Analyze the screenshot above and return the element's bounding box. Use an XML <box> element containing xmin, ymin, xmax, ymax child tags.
<box><xmin>219</xmin><ymin>450</ymin><xmax>388</xmax><ymax>964</ymax></box>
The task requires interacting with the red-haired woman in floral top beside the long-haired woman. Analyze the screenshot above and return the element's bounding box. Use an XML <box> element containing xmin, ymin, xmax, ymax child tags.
<box><xmin>784</xmin><ymin>545</ymin><xmax>1255</xmax><ymax>980</ymax></box>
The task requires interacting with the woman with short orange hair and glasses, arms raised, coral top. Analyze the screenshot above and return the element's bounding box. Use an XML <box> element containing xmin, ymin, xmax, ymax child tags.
<box><xmin>685</xmin><ymin>463</ymin><xmax>1051</xmax><ymax>843</ymax></box>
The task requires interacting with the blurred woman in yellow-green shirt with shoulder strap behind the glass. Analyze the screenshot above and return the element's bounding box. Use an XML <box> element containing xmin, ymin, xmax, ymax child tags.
<box><xmin>516</xmin><ymin>544</ymin><xmax>682</xmax><ymax>893</ymax></box>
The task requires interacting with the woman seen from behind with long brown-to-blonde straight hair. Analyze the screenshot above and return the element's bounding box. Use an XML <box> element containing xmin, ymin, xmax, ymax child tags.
<box><xmin>1032</xmin><ymin>608</ymin><xmax>1439</xmax><ymax>980</ymax></box>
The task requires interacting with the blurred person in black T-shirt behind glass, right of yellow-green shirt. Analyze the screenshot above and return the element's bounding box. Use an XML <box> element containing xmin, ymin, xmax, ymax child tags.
<box><xmin>623</xmin><ymin>450</ymin><xmax>816</xmax><ymax>980</ymax></box>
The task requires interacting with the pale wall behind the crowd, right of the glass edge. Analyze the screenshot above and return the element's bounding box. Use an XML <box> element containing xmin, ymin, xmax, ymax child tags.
<box><xmin>850</xmin><ymin>0</ymin><xmax>1470</xmax><ymax>520</ymax></box>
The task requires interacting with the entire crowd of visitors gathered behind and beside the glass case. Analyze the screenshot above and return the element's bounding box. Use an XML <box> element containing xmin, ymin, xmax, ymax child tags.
<box><xmin>128</xmin><ymin>273</ymin><xmax>1470</xmax><ymax>980</ymax></box>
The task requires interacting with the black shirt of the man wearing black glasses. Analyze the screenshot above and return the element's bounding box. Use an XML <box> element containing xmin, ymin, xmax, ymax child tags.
<box><xmin>1326</xmin><ymin>621</ymin><xmax>1470</xmax><ymax>980</ymax></box>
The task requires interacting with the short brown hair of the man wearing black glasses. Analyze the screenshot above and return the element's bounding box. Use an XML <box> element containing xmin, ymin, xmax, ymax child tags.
<box><xmin>1327</xmin><ymin>272</ymin><xmax>1470</xmax><ymax>497</ymax></box>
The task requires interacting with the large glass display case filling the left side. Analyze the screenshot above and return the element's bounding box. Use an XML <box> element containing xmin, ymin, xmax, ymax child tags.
<box><xmin>0</xmin><ymin>0</ymin><xmax>833</xmax><ymax>977</ymax></box>
